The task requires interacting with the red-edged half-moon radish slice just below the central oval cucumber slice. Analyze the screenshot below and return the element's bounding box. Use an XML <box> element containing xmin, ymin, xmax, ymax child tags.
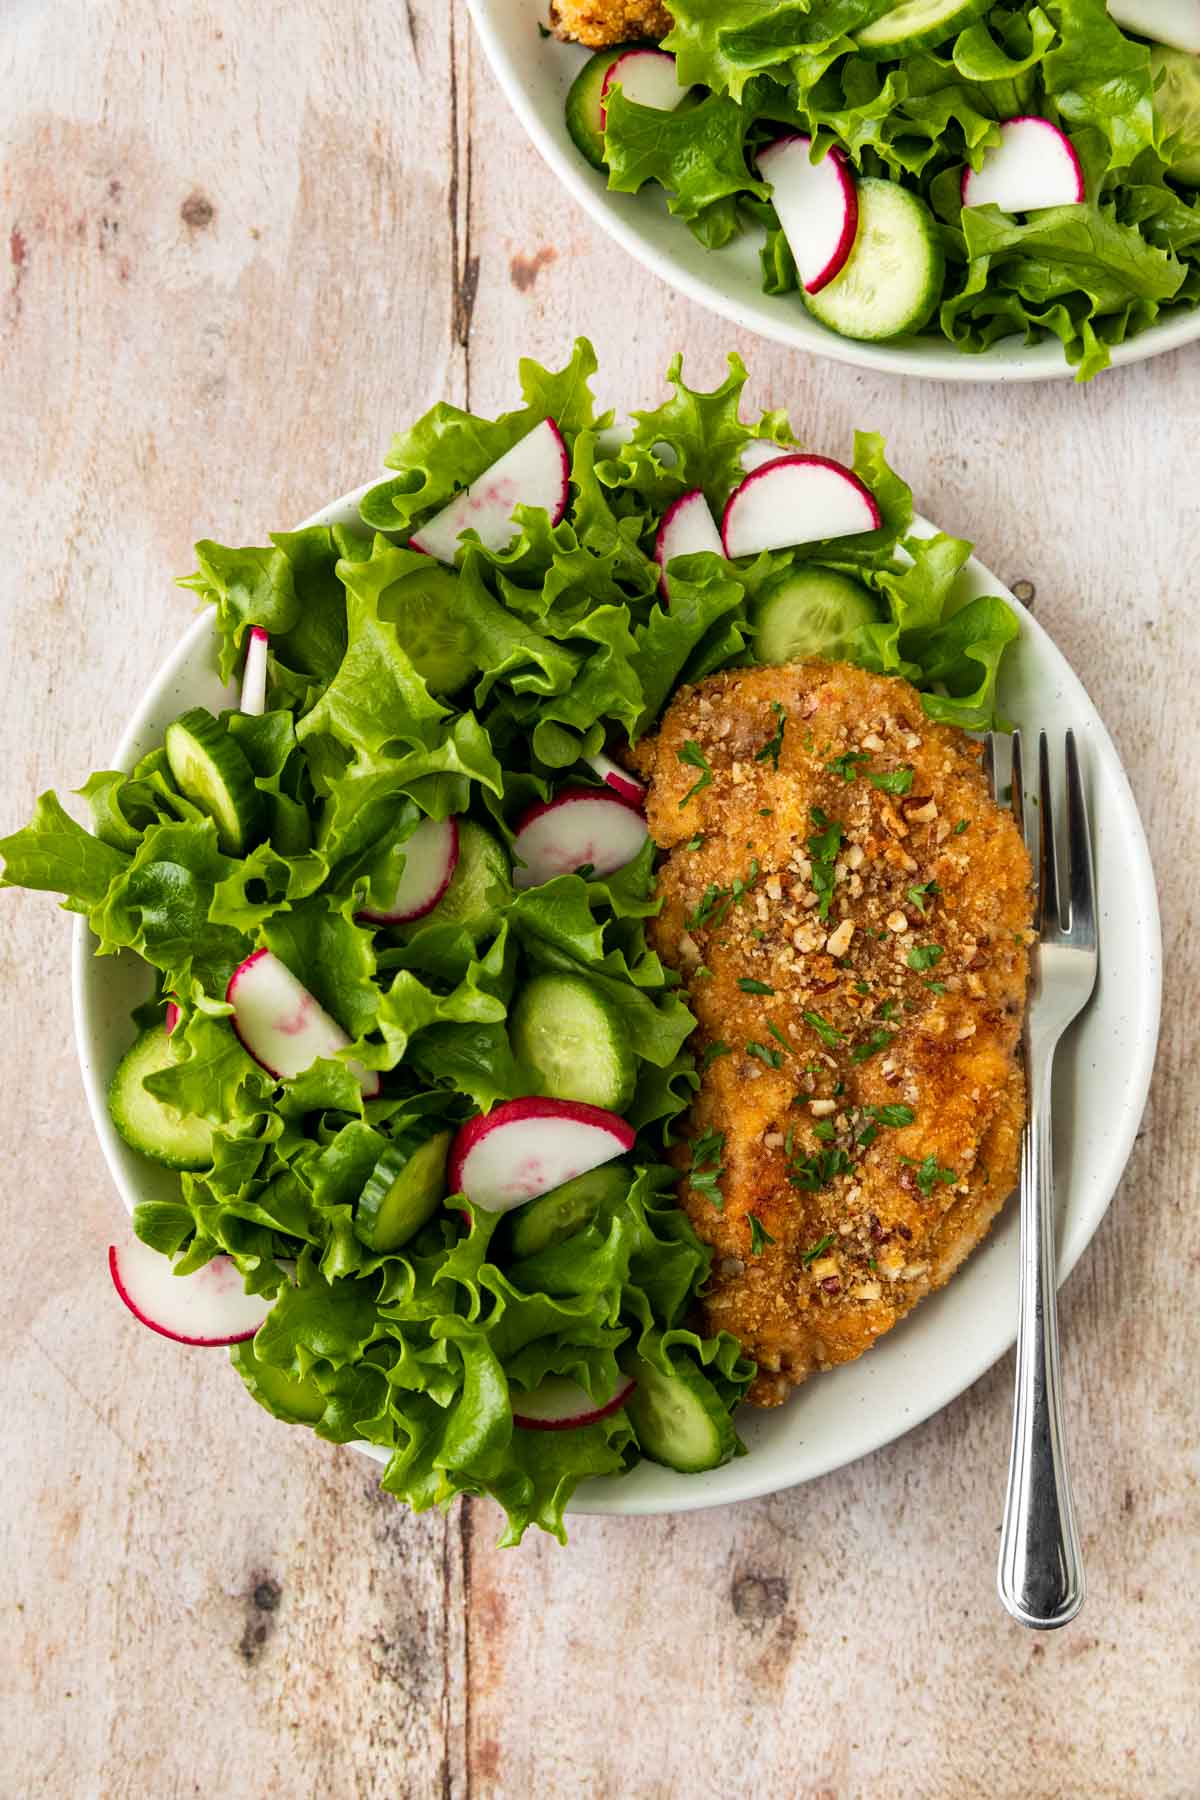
<box><xmin>448</xmin><ymin>1087</ymin><xmax>633</xmax><ymax>1213</ymax></box>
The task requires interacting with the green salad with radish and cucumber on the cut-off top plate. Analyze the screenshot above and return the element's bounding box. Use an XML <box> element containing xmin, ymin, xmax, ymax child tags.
<box><xmin>567</xmin><ymin>0</ymin><xmax>1200</xmax><ymax>380</ymax></box>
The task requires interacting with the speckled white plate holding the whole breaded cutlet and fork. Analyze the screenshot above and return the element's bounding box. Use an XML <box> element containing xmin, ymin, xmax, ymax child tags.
<box><xmin>72</xmin><ymin>486</ymin><xmax>1160</xmax><ymax>1514</ymax></box>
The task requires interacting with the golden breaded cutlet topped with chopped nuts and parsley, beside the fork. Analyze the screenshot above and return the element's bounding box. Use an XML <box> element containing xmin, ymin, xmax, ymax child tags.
<box><xmin>633</xmin><ymin>662</ymin><xmax>1033</xmax><ymax>1406</ymax></box>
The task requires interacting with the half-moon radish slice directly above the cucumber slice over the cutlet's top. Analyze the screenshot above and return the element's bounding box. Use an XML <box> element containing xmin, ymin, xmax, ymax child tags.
<box><xmin>721</xmin><ymin>454</ymin><xmax>880</xmax><ymax>558</ymax></box>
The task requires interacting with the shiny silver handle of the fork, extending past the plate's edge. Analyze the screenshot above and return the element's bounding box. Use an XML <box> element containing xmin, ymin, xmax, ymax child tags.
<box><xmin>997</xmin><ymin>1042</ymin><xmax>1085</xmax><ymax>1631</ymax></box>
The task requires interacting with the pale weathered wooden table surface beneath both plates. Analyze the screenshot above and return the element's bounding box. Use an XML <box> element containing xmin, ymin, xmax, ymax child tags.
<box><xmin>0</xmin><ymin>0</ymin><xmax>1200</xmax><ymax>1800</ymax></box>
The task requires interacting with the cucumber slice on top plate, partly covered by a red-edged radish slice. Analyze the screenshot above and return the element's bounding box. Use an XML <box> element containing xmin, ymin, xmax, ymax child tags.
<box><xmin>802</xmin><ymin>176</ymin><xmax>946</xmax><ymax>342</ymax></box>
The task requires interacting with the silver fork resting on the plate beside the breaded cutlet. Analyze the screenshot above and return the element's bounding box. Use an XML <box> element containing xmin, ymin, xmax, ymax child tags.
<box><xmin>986</xmin><ymin>731</ymin><xmax>1097</xmax><ymax>1631</ymax></box>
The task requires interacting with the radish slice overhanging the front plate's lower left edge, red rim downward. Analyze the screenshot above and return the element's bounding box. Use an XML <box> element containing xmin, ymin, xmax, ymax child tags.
<box><xmin>108</xmin><ymin>1238</ymin><xmax>275</xmax><ymax>1345</ymax></box>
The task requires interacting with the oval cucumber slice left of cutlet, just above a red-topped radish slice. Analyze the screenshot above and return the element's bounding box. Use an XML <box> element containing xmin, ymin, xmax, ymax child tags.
<box><xmin>509</xmin><ymin>974</ymin><xmax>637</xmax><ymax>1112</ymax></box>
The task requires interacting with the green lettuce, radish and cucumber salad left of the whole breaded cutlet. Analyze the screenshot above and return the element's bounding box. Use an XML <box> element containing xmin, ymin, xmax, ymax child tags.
<box><xmin>0</xmin><ymin>340</ymin><xmax>1016</xmax><ymax>1543</ymax></box>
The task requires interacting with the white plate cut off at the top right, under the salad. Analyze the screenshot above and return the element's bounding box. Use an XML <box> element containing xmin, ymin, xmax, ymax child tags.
<box><xmin>468</xmin><ymin>0</ymin><xmax>1200</xmax><ymax>382</ymax></box>
